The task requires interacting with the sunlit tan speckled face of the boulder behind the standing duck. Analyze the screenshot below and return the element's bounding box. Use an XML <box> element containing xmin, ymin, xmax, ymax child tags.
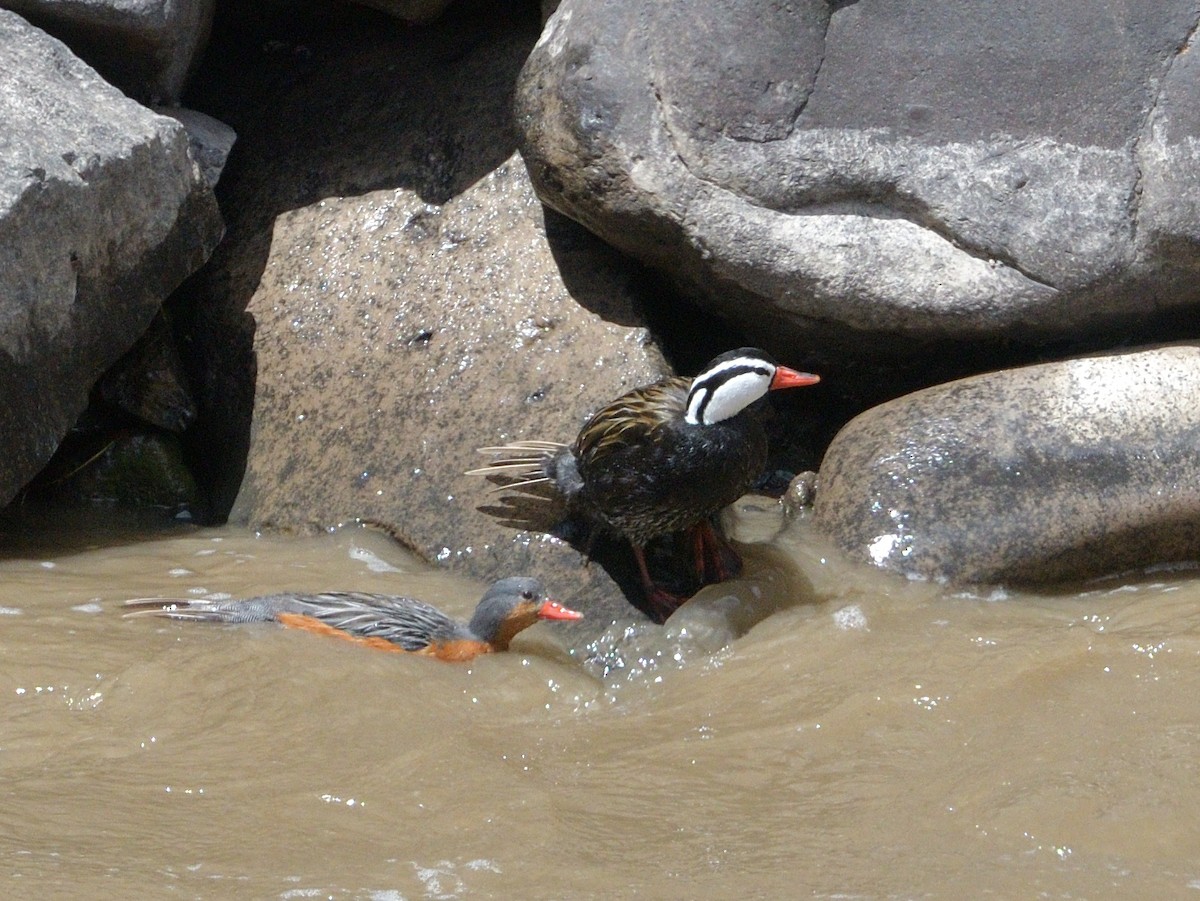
<box><xmin>230</xmin><ymin>157</ymin><xmax>665</xmax><ymax>628</ymax></box>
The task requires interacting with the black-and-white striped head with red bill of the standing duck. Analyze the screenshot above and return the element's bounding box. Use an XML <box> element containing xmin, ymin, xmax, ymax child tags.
<box><xmin>684</xmin><ymin>347</ymin><xmax>821</xmax><ymax>426</ymax></box>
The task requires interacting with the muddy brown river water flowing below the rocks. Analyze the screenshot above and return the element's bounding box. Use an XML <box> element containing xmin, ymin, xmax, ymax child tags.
<box><xmin>0</xmin><ymin>503</ymin><xmax>1200</xmax><ymax>900</ymax></box>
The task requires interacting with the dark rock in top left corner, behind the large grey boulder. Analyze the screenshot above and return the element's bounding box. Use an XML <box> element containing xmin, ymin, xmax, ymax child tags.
<box><xmin>0</xmin><ymin>0</ymin><xmax>215</xmax><ymax>103</ymax></box>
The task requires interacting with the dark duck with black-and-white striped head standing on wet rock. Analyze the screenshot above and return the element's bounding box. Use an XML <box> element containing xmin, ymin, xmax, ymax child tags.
<box><xmin>469</xmin><ymin>348</ymin><xmax>820</xmax><ymax>619</ymax></box>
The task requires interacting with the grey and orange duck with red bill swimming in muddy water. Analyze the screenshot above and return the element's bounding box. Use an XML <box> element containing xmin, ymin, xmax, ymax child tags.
<box><xmin>125</xmin><ymin>577</ymin><xmax>583</xmax><ymax>661</ymax></box>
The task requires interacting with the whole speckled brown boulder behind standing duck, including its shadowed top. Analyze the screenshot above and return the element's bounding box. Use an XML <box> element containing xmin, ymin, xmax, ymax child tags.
<box><xmin>181</xmin><ymin>2</ymin><xmax>666</xmax><ymax>632</ymax></box>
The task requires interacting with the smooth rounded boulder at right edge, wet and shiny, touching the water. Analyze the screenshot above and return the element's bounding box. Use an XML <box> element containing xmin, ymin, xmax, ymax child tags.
<box><xmin>815</xmin><ymin>344</ymin><xmax>1200</xmax><ymax>583</ymax></box>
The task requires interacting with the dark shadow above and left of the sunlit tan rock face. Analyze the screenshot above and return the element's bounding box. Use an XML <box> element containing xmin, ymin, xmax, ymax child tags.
<box><xmin>170</xmin><ymin>0</ymin><xmax>540</xmax><ymax>523</ymax></box>
